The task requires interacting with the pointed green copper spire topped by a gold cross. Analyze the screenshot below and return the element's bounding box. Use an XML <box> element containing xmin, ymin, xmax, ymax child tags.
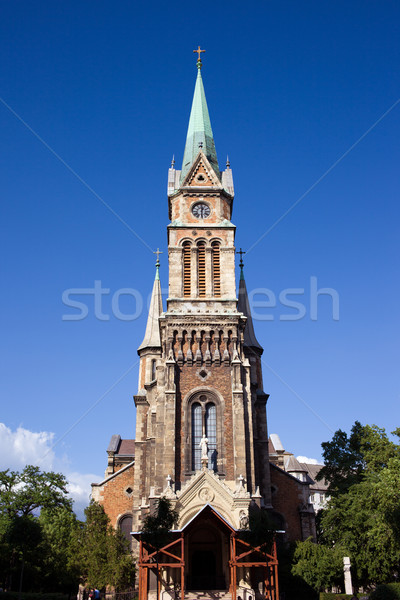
<box><xmin>181</xmin><ymin>48</ymin><xmax>220</xmax><ymax>183</ymax></box>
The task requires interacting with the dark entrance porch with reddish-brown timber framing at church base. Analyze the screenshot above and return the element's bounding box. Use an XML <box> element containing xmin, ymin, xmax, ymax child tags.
<box><xmin>135</xmin><ymin>504</ymin><xmax>279</xmax><ymax>600</ymax></box>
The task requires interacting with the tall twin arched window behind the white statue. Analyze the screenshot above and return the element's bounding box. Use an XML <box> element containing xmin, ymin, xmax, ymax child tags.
<box><xmin>191</xmin><ymin>396</ymin><xmax>217</xmax><ymax>471</ymax></box>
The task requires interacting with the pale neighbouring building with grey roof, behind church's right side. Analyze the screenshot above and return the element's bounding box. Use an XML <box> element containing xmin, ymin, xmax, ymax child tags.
<box><xmin>268</xmin><ymin>433</ymin><xmax>329</xmax><ymax>513</ymax></box>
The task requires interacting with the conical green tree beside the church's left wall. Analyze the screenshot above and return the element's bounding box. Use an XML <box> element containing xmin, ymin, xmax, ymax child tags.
<box><xmin>69</xmin><ymin>501</ymin><xmax>135</xmax><ymax>589</ymax></box>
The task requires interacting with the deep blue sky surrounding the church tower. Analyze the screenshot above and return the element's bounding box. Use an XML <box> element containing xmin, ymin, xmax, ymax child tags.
<box><xmin>0</xmin><ymin>0</ymin><xmax>400</xmax><ymax>516</ymax></box>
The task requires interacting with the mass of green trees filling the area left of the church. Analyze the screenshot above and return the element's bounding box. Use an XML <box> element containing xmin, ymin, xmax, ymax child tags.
<box><xmin>0</xmin><ymin>466</ymin><xmax>134</xmax><ymax>593</ymax></box>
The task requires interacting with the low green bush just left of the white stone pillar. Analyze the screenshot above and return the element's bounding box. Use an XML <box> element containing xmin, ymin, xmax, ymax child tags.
<box><xmin>292</xmin><ymin>538</ymin><xmax>345</xmax><ymax>592</ymax></box>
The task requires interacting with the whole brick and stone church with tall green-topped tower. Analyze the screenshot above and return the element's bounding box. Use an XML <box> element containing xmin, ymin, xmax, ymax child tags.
<box><xmin>92</xmin><ymin>48</ymin><xmax>315</xmax><ymax>600</ymax></box>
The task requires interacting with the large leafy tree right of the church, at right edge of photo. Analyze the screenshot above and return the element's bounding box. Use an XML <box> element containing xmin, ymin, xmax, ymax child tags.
<box><xmin>294</xmin><ymin>421</ymin><xmax>400</xmax><ymax>587</ymax></box>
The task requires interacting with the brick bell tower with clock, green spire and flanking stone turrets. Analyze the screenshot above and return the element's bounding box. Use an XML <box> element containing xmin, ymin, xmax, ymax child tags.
<box><xmin>133</xmin><ymin>48</ymin><xmax>271</xmax><ymax>530</ymax></box>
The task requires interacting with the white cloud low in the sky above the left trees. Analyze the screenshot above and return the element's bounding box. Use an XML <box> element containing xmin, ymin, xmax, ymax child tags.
<box><xmin>0</xmin><ymin>423</ymin><xmax>102</xmax><ymax>519</ymax></box>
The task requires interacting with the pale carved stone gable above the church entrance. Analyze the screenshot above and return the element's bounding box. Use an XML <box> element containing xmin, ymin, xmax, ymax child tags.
<box><xmin>175</xmin><ymin>470</ymin><xmax>251</xmax><ymax>529</ymax></box>
